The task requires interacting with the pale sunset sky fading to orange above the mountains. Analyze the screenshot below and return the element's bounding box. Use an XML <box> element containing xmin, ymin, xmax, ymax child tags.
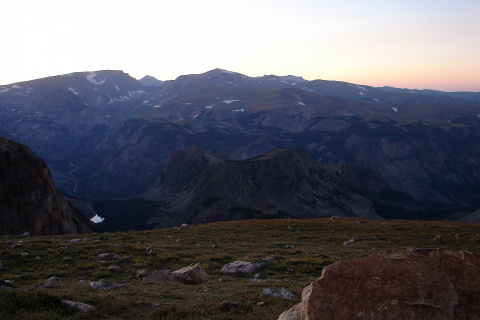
<box><xmin>0</xmin><ymin>0</ymin><xmax>480</xmax><ymax>91</ymax></box>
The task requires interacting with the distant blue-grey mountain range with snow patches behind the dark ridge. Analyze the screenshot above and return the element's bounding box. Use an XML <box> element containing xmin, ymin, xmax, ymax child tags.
<box><xmin>0</xmin><ymin>69</ymin><xmax>480</xmax><ymax>228</ymax></box>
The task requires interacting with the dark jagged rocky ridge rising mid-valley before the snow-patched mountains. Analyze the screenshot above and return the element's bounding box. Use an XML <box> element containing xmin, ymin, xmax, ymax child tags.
<box><xmin>144</xmin><ymin>147</ymin><xmax>418</xmax><ymax>226</ymax></box>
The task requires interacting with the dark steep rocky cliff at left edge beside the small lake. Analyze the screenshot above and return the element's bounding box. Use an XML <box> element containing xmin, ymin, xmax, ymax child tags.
<box><xmin>0</xmin><ymin>138</ymin><xmax>93</xmax><ymax>235</ymax></box>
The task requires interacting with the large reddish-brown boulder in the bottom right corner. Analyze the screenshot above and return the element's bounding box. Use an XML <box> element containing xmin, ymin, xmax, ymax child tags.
<box><xmin>279</xmin><ymin>248</ymin><xmax>480</xmax><ymax>320</ymax></box>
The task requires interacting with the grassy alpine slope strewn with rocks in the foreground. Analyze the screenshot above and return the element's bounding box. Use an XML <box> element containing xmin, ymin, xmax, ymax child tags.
<box><xmin>0</xmin><ymin>219</ymin><xmax>480</xmax><ymax>320</ymax></box>
